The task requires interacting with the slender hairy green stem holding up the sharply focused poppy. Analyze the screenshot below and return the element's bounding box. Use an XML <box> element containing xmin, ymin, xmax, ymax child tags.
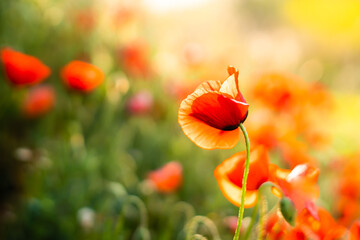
<box><xmin>233</xmin><ymin>123</ymin><xmax>250</xmax><ymax>240</ymax></box>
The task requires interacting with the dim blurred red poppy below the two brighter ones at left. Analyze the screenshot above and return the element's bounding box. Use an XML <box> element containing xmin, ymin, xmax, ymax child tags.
<box><xmin>23</xmin><ymin>86</ymin><xmax>55</xmax><ymax>117</ymax></box>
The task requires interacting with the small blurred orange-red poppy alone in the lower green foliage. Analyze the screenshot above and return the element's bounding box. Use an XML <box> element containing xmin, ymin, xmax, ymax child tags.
<box><xmin>148</xmin><ymin>162</ymin><xmax>183</xmax><ymax>193</ymax></box>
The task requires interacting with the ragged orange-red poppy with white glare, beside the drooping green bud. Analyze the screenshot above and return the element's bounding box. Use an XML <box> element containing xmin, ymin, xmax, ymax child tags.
<box><xmin>270</xmin><ymin>164</ymin><xmax>320</xmax><ymax>219</ymax></box>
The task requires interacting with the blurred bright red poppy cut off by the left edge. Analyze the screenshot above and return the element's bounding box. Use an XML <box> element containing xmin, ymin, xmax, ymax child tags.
<box><xmin>1</xmin><ymin>47</ymin><xmax>51</xmax><ymax>86</ymax></box>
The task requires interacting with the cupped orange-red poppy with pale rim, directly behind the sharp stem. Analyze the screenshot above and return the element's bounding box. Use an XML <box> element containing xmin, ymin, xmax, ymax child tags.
<box><xmin>214</xmin><ymin>147</ymin><xmax>269</xmax><ymax>208</ymax></box>
